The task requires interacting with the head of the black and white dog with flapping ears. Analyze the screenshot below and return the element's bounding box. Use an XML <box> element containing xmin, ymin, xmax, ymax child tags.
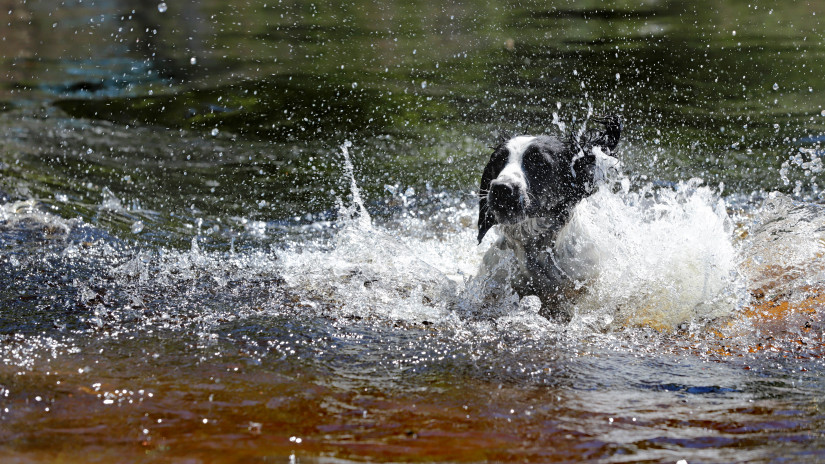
<box><xmin>478</xmin><ymin>116</ymin><xmax>622</xmax><ymax>243</ymax></box>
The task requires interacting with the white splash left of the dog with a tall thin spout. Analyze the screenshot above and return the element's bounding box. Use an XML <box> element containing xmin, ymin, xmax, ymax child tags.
<box><xmin>278</xmin><ymin>142</ymin><xmax>471</xmax><ymax>322</ymax></box>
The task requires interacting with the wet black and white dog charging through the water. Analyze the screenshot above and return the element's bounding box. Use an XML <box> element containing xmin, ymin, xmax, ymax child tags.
<box><xmin>478</xmin><ymin>115</ymin><xmax>622</xmax><ymax>317</ymax></box>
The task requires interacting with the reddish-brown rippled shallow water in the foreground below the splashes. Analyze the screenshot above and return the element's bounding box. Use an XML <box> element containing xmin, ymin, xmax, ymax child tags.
<box><xmin>0</xmin><ymin>297</ymin><xmax>824</xmax><ymax>463</ymax></box>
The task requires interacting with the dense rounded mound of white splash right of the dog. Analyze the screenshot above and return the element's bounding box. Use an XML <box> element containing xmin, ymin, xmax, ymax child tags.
<box><xmin>556</xmin><ymin>180</ymin><xmax>743</xmax><ymax>327</ymax></box>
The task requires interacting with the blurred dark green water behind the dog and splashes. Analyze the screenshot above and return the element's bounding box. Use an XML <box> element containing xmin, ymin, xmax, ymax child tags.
<box><xmin>0</xmin><ymin>0</ymin><xmax>825</xmax><ymax>246</ymax></box>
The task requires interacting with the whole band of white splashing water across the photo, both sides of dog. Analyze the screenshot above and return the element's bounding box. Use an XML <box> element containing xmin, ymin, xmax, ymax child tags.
<box><xmin>0</xmin><ymin>143</ymin><xmax>825</xmax><ymax>336</ymax></box>
